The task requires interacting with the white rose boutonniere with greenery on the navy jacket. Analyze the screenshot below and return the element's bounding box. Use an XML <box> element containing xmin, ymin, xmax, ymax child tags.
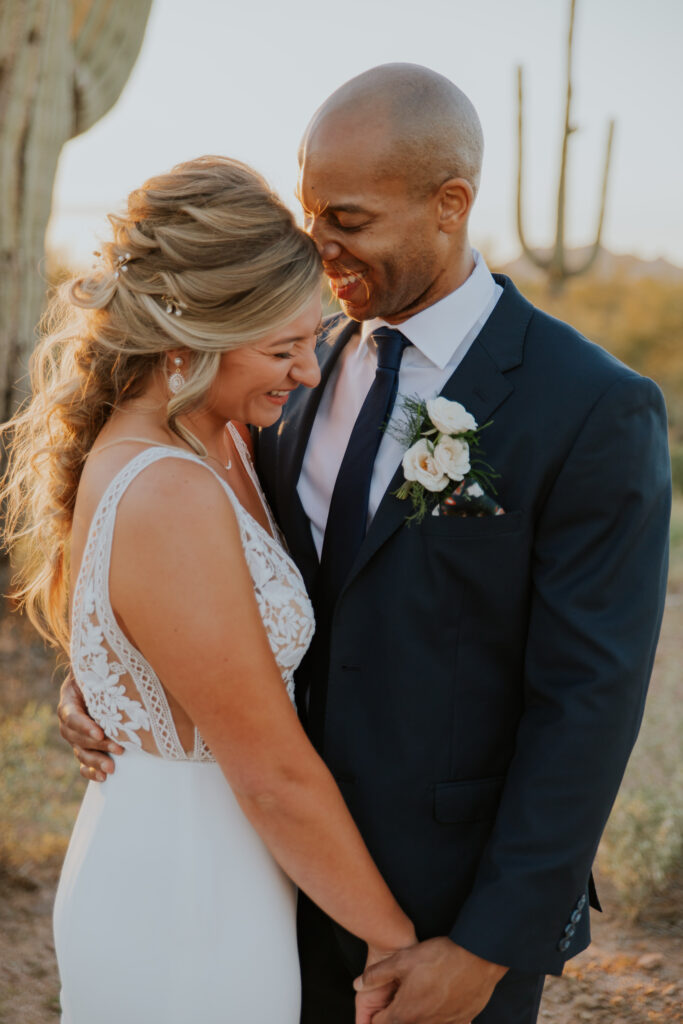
<box><xmin>392</xmin><ymin>397</ymin><xmax>503</xmax><ymax>522</ymax></box>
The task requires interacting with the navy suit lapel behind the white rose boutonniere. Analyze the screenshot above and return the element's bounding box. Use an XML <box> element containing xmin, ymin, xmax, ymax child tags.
<box><xmin>346</xmin><ymin>274</ymin><xmax>533</xmax><ymax>586</ymax></box>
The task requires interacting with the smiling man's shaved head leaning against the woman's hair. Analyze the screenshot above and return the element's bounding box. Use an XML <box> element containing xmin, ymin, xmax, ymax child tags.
<box><xmin>299</xmin><ymin>65</ymin><xmax>483</xmax><ymax>323</ymax></box>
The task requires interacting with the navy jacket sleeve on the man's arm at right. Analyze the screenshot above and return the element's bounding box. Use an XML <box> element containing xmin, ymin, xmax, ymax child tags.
<box><xmin>451</xmin><ymin>375</ymin><xmax>671</xmax><ymax>974</ymax></box>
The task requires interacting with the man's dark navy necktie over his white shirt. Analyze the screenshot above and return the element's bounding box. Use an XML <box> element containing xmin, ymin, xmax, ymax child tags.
<box><xmin>316</xmin><ymin>327</ymin><xmax>412</xmax><ymax>617</ymax></box>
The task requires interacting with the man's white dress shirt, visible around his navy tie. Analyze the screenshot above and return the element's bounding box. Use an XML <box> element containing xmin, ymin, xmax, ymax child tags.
<box><xmin>297</xmin><ymin>250</ymin><xmax>503</xmax><ymax>558</ymax></box>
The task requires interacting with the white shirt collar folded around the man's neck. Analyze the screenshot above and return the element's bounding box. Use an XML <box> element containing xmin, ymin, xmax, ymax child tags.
<box><xmin>358</xmin><ymin>249</ymin><xmax>496</xmax><ymax>370</ymax></box>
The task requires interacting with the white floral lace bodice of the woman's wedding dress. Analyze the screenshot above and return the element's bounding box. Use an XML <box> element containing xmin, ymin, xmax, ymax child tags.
<box><xmin>71</xmin><ymin>444</ymin><xmax>314</xmax><ymax>761</ymax></box>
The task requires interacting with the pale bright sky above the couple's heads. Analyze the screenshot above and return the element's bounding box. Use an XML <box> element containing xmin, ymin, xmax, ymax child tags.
<box><xmin>49</xmin><ymin>0</ymin><xmax>683</xmax><ymax>265</ymax></box>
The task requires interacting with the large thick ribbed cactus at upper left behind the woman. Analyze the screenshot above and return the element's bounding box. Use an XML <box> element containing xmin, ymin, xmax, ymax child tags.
<box><xmin>0</xmin><ymin>0</ymin><xmax>152</xmax><ymax>421</ymax></box>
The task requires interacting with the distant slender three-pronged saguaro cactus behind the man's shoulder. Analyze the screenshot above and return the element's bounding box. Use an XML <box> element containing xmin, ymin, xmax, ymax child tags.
<box><xmin>517</xmin><ymin>0</ymin><xmax>614</xmax><ymax>293</ymax></box>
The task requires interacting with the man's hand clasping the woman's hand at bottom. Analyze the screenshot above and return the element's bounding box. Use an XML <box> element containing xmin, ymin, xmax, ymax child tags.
<box><xmin>354</xmin><ymin>938</ymin><xmax>508</xmax><ymax>1024</ymax></box>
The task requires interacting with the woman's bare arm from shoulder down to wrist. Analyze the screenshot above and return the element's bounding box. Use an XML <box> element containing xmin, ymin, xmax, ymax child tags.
<box><xmin>110</xmin><ymin>460</ymin><xmax>415</xmax><ymax>949</ymax></box>
